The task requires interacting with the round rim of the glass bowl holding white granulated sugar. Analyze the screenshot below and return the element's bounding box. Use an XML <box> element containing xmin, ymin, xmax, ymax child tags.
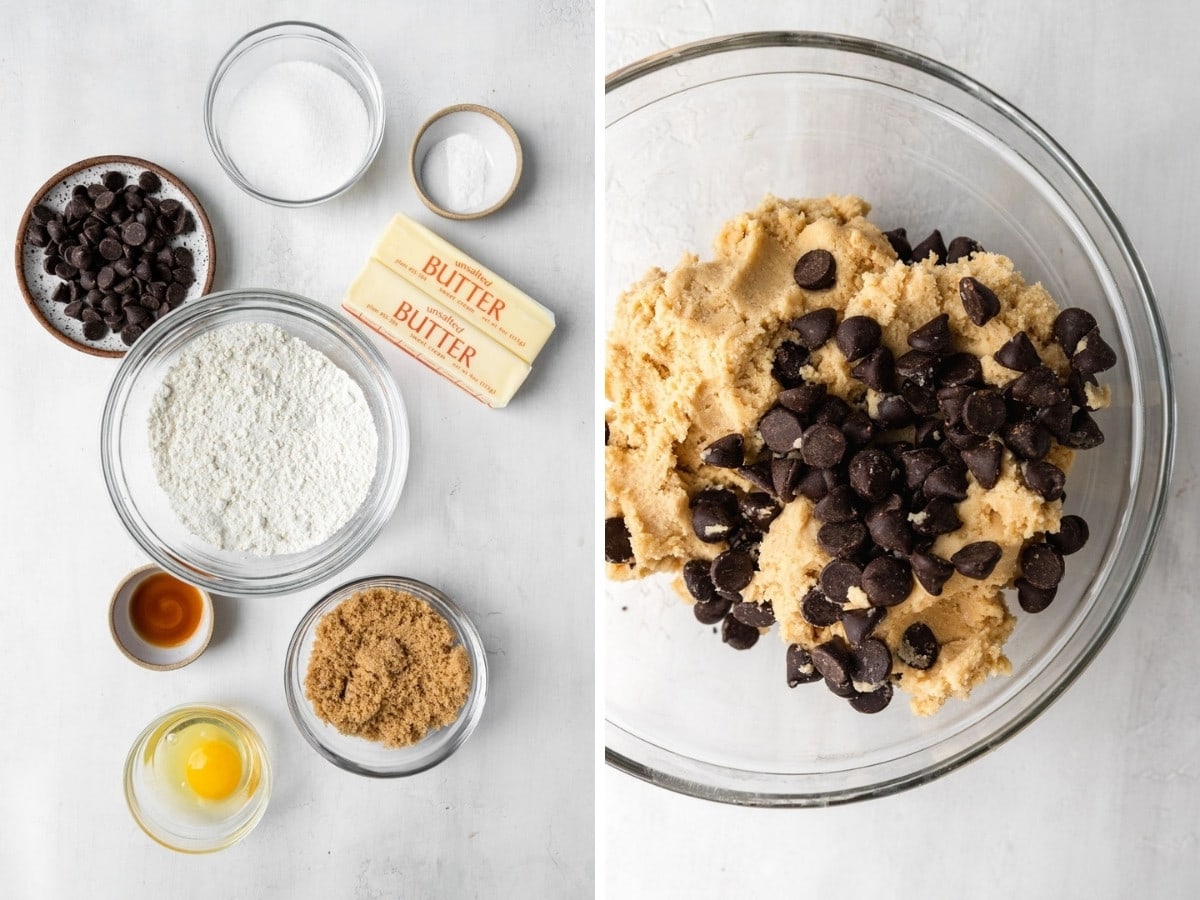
<box><xmin>204</xmin><ymin>19</ymin><xmax>388</xmax><ymax>208</ymax></box>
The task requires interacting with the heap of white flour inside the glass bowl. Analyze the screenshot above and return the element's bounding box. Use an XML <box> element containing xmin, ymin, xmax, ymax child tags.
<box><xmin>149</xmin><ymin>323</ymin><xmax>379</xmax><ymax>556</ymax></box>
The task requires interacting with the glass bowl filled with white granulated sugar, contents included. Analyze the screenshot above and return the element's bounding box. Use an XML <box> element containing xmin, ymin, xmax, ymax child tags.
<box><xmin>204</xmin><ymin>22</ymin><xmax>386</xmax><ymax>206</ymax></box>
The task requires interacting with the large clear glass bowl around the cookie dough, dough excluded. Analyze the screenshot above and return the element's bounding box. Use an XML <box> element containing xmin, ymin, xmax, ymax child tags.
<box><xmin>605</xmin><ymin>32</ymin><xmax>1175</xmax><ymax>806</ymax></box>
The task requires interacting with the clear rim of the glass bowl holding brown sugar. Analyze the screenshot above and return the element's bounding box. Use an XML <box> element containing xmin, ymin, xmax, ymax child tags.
<box><xmin>283</xmin><ymin>575</ymin><xmax>487</xmax><ymax>778</ymax></box>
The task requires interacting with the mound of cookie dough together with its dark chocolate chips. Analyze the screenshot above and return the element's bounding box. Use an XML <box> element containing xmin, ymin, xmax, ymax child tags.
<box><xmin>605</xmin><ymin>197</ymin><xmax>1116</xmax><ymax>715</ymax></box>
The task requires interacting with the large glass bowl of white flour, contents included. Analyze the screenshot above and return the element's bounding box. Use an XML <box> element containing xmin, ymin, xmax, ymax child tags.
<box><xmin>101</xmin><ymin>290</ymin><xmax>408</xmax><ymax>595</ymax></box>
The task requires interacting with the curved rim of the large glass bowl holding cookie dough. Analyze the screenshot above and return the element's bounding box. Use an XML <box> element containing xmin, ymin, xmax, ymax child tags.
<box><xmin>605</xmin><ymin>31</ymin><xmax>1176</xmax><ymax>806</ymax></box>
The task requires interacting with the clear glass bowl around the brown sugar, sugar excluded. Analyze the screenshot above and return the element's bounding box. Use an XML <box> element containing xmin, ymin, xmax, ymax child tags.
<box><xmin>283</xmin><ymin>575</ymin><xmax>487</xmax><ymax>778</ymax></box>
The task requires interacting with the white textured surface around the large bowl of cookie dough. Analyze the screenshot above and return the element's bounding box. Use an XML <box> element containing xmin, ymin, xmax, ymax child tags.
<box><xmin>609</xmin><ymin>0</ymin><xmax>1200</xmax><ymax>900</ymax></box>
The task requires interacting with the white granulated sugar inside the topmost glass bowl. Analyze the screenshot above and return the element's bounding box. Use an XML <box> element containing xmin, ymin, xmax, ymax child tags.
<box><xmin>222</xmin><ymin>60</ymin><xmax>371</xmax><ymax>200</ymax></box>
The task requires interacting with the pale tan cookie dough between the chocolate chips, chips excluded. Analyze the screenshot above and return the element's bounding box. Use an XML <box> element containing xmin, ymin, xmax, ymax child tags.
<box><xmin>605</xmin><ymin>196</ymin><xmax>1106</xmax><ymax>715</ymax></box>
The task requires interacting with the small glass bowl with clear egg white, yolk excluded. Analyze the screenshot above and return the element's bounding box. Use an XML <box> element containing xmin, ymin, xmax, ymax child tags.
<box><xmin>125</xmin><ymin>704</ymin><xmax>271</xmax><ymax>853</ymax></box>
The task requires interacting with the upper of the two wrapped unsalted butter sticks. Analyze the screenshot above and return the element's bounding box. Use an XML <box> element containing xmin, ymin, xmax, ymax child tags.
<box><xmin>371</xmin><ymin>215</ymin><xmax>554</xmax><ymax>362</ymax></box>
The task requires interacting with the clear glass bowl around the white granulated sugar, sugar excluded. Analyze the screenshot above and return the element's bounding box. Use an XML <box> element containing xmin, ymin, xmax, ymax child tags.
<box><xmin>204</xmin><ymin>22</ymin><xmax>388</xmax><ymax>206</ymax></box>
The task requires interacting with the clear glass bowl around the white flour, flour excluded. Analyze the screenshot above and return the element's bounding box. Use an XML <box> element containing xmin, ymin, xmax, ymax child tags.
<box><xmin>100</xmin><ymin>289</ymin><xmax>408</xmax><ymax>596</ymax></box>
